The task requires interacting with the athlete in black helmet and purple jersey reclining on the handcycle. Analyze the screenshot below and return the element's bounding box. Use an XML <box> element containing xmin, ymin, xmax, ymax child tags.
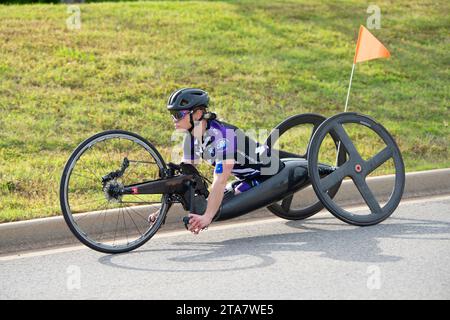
<box><xmin>149</xmin><ymin>88</ymin><xmax>276</xmax><ymax>234</ymax></box>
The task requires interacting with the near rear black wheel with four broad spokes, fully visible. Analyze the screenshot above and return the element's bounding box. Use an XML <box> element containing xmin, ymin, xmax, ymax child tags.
<box><xmin>308</xmin><ymin>112</ymin><xmax>405</xmax><ymax>226</ymax></box>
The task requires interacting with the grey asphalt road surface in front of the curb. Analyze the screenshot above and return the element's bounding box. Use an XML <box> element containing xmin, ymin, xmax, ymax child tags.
<box><xmin>0</xmin><ymin>195</ymin><xmax>450</xmax><ymax>299</ymax></box>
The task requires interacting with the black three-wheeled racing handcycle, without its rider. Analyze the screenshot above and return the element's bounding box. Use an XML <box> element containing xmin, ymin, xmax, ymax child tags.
<box><xmin>60</xmin><ymin>112</ymin><xmax>405</xmax><ymax>253</ymax></box>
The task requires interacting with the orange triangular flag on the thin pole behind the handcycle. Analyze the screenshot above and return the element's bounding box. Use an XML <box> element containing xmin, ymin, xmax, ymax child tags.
<box><xmin>353</xmin><ymin>26</ymin><xmax>391</xmax><ymax>63</ymax></box>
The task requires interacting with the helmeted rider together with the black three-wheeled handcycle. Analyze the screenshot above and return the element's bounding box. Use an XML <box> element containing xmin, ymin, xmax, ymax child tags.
<box><xmin>60</xmin><ymin>89</ymin><xmax>405</xmax><ymax>253</ymax></box>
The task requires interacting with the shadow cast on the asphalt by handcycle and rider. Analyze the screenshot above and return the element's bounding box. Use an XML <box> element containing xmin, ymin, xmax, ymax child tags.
<box><xmin>99</xmin><ymin>217</ymin><xmax>450</xmax><ymax>272</ymax></box>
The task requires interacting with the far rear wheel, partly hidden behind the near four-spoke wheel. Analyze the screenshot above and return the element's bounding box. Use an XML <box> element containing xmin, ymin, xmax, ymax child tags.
<box><xmin>265</xmin><ymin>113</ymin><xmax>345</xmax><ymax>220</ymax></box>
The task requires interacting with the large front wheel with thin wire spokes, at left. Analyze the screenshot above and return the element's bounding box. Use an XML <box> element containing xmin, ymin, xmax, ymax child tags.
<box><xmin>60</xmin><ymin>130</ymin><xmax>170</xmax><ymax>253</ymax></box>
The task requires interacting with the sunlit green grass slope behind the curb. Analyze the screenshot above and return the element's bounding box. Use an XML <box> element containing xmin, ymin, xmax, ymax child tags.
<box><xmin>0</xmin><ymin>0</ymin><xmax>450</xmax><ymax>222</ymax></box>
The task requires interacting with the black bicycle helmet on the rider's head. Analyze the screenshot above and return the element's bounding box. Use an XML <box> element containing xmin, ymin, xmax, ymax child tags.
<box><xmin>167</xmin><ymin>88</ymin><xmax>209</xmax><ymax>111</ymax></box>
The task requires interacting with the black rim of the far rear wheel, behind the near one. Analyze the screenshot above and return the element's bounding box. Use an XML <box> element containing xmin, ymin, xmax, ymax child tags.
<box><xmin>265</xmin><ymin>113</ymin><xmax>345</xmax><ymax>220</ymax></box>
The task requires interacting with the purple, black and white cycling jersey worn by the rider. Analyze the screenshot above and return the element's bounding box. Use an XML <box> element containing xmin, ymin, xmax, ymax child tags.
<box><xmin>183</xmin><ymin>120</ymin><xmax>267</xmax><ymax>180</ymax></box>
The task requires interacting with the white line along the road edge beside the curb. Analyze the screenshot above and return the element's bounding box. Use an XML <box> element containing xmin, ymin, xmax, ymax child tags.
<box><xmin>0</xmin><ymin>195</ymin><xmax>450</xmax><ymax>262</ymax></box>
